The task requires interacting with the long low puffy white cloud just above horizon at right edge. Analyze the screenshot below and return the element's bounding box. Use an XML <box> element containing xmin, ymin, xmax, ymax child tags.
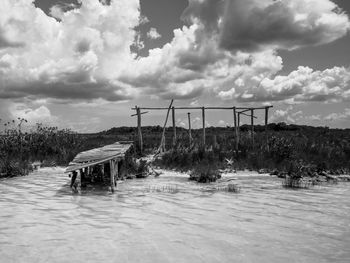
<box><xmin>224</xmin><ymin>66</ymin><xmax>350</xmax><ymax>103</ymax></box>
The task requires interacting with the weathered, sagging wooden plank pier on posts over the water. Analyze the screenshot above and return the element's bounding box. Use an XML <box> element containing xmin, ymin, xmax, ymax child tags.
<box><xmin>66</xmin><ymin>142</ymin><xmax>133</xmax><ymax>192</ymax></box>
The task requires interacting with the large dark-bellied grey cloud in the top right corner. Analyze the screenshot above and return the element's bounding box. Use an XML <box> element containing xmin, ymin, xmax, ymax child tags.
<box><xmin>220</xmin><ymin>0</ymin><xmax>350</xmax><ymax>51</ymax></box>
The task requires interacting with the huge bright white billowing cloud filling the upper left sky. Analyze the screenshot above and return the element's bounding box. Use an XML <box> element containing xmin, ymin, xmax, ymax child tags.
<box><xmin>0</xmin><ymin>0</ymin><xmax>140</xmax><ymax>101</ymax></box>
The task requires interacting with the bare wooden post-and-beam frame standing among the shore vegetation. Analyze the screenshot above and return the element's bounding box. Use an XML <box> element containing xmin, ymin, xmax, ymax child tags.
<box><xmin>131</xmin><ymin>105</ymin><xmax>273</xmax><ymax>153</ymax></box>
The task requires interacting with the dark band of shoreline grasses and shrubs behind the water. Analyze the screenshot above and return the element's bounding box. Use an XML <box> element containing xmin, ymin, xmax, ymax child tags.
<box><xmin>0</xmin><ymin>119</ymin><xmax>350</xmax><ymax>187</ymax></box>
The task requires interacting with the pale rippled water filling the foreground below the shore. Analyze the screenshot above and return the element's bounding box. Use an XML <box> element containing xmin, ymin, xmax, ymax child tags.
<box><xmin>0</xmin><ymin>168</ymin><xmax>350</xmax><ymax>263</ymax></box>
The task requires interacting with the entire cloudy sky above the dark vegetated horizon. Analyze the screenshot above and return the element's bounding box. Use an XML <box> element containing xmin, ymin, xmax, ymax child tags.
<box><xmin>0</xmin><ymin>0</ymin><xmax>350</xmax><ymax>132</ymax></box>
